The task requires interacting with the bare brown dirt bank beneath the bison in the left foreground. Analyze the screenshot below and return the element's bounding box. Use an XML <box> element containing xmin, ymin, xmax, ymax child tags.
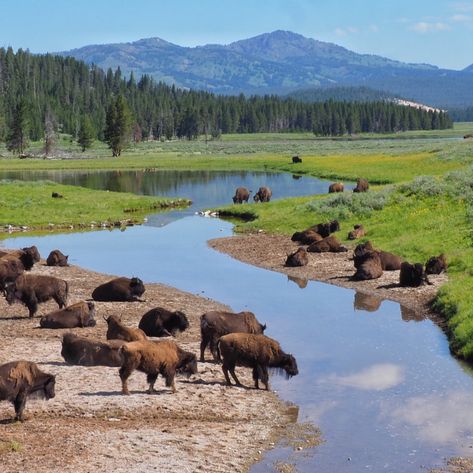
<box><xmin>0</xmin><ymin>256</ymin><xmax>316</xmax><ymax>473</ymax></box>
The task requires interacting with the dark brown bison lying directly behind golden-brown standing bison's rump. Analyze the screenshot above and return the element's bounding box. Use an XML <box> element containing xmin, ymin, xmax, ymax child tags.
<box><xmin>61</xmin><ymin>333</ymin><xmax>126</xmax><ymax>367</ymax></box>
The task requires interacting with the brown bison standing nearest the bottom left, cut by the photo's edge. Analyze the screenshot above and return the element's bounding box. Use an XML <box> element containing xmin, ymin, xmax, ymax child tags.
<box><xmin>0</xmin><ymin>360</ymin><xmax>56</xmax><ymax>421</ymax></box>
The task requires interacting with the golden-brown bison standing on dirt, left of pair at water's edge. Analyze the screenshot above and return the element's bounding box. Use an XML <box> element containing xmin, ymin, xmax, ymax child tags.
<box><xmin>119</xmin><ymin>340</ymin><xmax>197</xmax><ymax>394</ymax></box>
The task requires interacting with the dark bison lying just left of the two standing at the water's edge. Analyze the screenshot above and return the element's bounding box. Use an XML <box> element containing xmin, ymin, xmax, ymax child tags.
<box><xmin>138</xmin><ymin>307</ymin><xmax>189</xmax><ymax>337</ymax></box>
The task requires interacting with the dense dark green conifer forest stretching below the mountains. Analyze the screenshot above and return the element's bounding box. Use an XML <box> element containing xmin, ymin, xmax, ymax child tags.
<box><xmin>0</xmin><ymin>48</ymin><xmax>452</xmax><ymax>154</ymax></box>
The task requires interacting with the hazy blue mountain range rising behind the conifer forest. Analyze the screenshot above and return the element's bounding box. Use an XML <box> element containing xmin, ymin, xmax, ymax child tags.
<box><xmin>59</xmin><ymin>31</ymin><xmax>473</xmax><ymax>108</ymax></box>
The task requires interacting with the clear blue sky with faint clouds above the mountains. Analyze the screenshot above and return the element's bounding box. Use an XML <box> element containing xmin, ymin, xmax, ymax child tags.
<box><xmin>0</xmin><ymin>0</ymin><xmax>473</xmax><ymax>69</ymax></box>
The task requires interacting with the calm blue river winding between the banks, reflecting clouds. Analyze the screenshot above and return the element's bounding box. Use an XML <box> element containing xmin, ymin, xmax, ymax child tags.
<box><xmin>1</xmin><ymin>173</ymin><xmax>473</xmax><ymax>473</ymax></box>
